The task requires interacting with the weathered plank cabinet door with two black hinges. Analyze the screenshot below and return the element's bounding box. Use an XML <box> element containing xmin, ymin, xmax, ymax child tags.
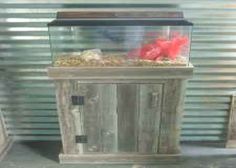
<box><xmin>70</xmin><ymin>82</ymin><xmax>162</xmax><ymax>153</ymax></box>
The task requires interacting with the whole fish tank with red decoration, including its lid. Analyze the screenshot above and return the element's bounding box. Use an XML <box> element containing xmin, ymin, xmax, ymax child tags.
<box><xmin>48</xmin><ymin>11</ymin><xmax>193</xmax><ymax>67</ymax></box>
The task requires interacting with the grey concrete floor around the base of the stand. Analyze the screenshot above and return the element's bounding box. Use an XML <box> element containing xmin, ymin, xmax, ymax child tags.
<box><xmin>0</xmin><ymin>142</ymin><xmax>236</xmax><ymax>168</ymax></box>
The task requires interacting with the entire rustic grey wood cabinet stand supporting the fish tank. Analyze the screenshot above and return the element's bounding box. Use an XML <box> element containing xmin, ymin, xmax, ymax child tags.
<box><xmin>48</xmin><ymin>65</ymin><xmax>193</xmax><ymax>164</ymax></box>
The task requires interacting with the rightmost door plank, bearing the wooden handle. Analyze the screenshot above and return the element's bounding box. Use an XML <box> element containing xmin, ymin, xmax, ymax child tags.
<box><xmin>138</xmin><ymin>84</ymin><xmax>162</xmax><ymax>153</ymax></box>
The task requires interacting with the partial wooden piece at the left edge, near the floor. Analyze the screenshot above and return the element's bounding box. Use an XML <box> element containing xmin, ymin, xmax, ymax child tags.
<box><xmin>0</xmin><ymin>111</ymin><xmax>12</xmax><ymax>161</ymax></box>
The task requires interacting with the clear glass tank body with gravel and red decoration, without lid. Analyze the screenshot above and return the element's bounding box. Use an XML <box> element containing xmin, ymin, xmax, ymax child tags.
<box><xmin>49</xmin><ymin>25</ymin><xmax>191</xmax><ymax>67</ymax></box>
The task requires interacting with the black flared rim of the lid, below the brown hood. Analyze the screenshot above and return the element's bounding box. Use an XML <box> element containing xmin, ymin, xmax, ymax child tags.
<box><xmin>48</xmin><ymin>19</ymin><xmax>193</xmax><ymax>26</ymax></box>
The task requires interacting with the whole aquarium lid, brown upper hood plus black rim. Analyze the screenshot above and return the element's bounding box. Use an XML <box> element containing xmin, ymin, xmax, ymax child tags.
<box><xmin>48</xmin><ymin>10</ymin><xmax>193</xmax><ymax>26</ymax></box>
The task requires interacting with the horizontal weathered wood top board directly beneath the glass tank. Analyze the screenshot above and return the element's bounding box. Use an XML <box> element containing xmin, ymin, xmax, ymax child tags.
<box><xmin>48</xmin><ymin>65</ymin><xmax>193</xmax><ymax>80</ymax></box>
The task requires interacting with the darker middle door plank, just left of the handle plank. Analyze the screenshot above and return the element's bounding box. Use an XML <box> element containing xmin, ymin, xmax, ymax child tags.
<box><xmin>117</xmin><ymin>84</ymin><xmax>139</xmax><ymax>152</ymax></box>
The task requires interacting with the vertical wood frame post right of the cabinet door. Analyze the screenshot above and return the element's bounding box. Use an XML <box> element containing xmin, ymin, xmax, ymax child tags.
<box><xmin>158</xmin><ymin>79</ymin><xmax>185</xmax><ymax>154</ymax></box>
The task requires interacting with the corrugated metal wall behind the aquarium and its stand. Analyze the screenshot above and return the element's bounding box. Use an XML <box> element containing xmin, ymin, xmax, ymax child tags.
<box><xmin>0</xmin><ymin>0</ymin><xmax>236</xmax><ymax>141</ymax></box>
